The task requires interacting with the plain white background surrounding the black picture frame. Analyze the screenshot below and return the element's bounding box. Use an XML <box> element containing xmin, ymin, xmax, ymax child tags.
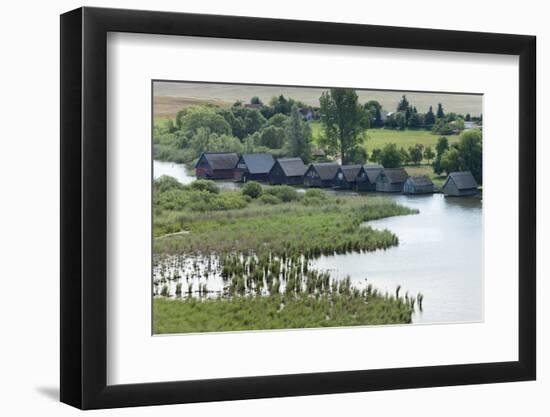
<box><xmin>0</xmin><ymin>0</ymin><xmax>550</xmax><ymax>417</ymax></box>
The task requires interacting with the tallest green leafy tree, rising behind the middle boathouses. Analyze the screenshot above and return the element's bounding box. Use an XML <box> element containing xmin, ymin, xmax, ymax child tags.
<box><xmin>319</xmin><ymin>88</ymin><xmax>368</xmax><ymax>164</ymax></box>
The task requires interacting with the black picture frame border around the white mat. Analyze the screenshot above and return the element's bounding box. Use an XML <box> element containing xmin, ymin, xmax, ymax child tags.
<box><xmin>60</xmin><ymin>7</ymin><xmax>536</xmax><ymax>409</ymax></box>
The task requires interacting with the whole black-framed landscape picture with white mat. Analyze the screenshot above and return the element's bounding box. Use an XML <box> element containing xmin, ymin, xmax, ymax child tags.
<box><xmin>60</xmin><ymin>7</ymin><xmax>536</xmax><ymax>409</ymax></box>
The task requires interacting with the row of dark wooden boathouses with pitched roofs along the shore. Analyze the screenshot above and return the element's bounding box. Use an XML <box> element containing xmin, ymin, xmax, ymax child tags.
<box><xmin>195</xmin><ymin>152</ymin><xmax>478</xmax><ymax>196</ymax></box>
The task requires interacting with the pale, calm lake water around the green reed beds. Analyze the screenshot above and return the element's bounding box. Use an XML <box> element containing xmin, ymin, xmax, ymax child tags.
<box><xmin>154</xmin><ymin>161</ymin><xmax>483</xmax><ymax>323</ymax></box>
